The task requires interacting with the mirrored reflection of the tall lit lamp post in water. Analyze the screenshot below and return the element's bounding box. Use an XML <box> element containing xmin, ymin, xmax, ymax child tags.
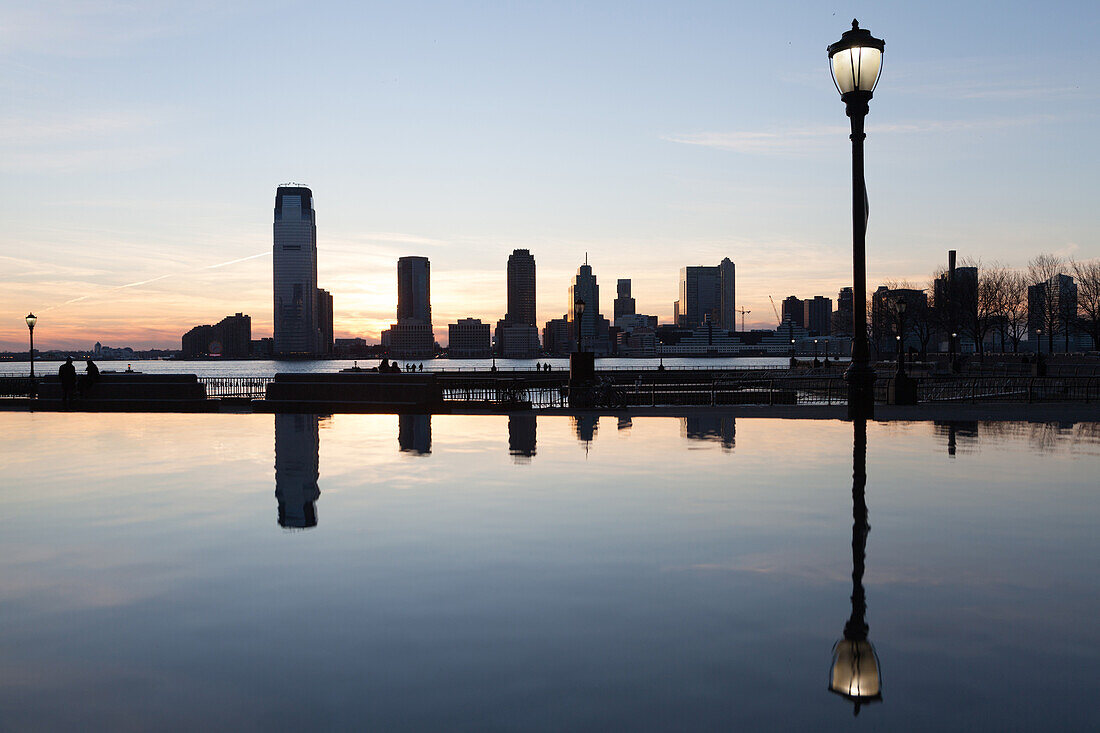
<box><xmin>828</xmin><ymin>418</ymin><xmax>882</xmax><ymax>715</ymax></box>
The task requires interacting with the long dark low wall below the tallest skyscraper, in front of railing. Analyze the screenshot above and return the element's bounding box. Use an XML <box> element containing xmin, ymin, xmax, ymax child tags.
<box><xmin>253</xmin><ymin>372</ymin><xmax>443</xmax><ymax>413</ymax></box>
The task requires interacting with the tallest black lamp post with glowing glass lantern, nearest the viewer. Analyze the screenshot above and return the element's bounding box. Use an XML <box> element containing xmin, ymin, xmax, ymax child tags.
<box><xmin>827</xmin><ymin>21</ymin><xmax>886</xmax><ymax>419</ymax></box>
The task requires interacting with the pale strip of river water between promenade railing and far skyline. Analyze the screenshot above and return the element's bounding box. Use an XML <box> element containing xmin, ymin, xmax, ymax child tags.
<box><xmin>0</xmin><ymin>355</ymin><xmax>849</xmax><ymax>376</ymax></box>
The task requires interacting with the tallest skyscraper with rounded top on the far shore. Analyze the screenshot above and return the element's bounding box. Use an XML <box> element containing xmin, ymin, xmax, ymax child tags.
<box><xmin>272</xmin><ymin>186</ymin><xmax>321</xmax><ymax>357</ymax></box>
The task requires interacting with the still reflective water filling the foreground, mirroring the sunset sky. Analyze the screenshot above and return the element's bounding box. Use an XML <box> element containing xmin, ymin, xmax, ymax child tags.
<box><xmin>0</xmin><ymin>413</ymin><xmax>1100</xmax><ymax>731</ymax></box>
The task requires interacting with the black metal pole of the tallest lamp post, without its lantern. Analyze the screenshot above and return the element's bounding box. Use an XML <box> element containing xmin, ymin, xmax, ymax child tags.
<box><xmin>844</xmin><ymin>91</ymin><xmax>875</xmax><ymax>419</ymax></box>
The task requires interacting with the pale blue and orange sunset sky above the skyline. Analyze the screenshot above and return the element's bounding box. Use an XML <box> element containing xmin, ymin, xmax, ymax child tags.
<box><xmin>0</xmin><ymin>0</ymin><xmax>1100</xmax><ymax>350</ymax></box>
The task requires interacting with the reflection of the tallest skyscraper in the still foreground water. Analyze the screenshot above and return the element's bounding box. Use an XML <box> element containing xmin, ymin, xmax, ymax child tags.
<box><xmin>275</xmin><ymin>415</ymin><xmax>321</xmax><ymax>529</ymax></box>
